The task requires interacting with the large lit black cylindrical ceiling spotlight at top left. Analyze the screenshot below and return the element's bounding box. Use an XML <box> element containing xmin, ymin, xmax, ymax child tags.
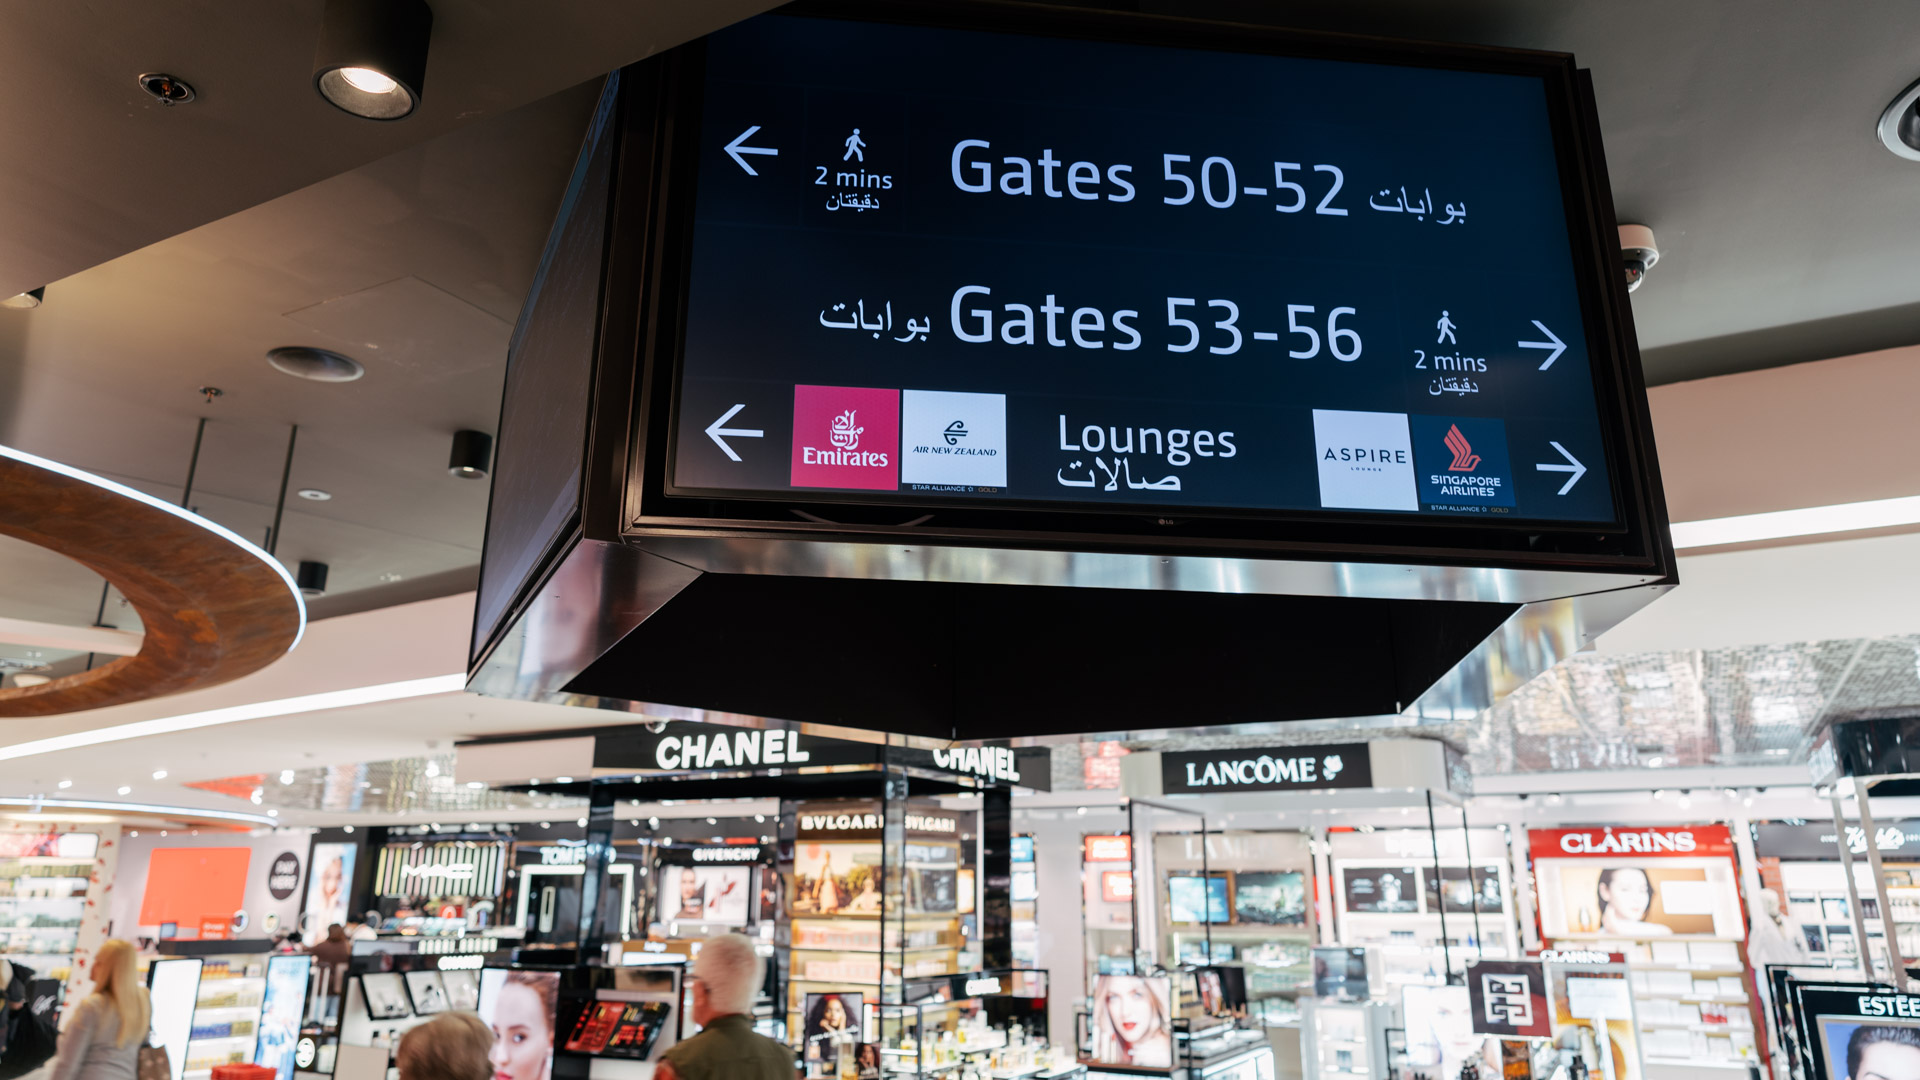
<box><xmin>313</xmin><ymin>0</ymin><xmax>434</xmax><ymax>119</ymax></box>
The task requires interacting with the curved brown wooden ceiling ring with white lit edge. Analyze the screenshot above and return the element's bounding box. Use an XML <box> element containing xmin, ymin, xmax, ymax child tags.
<box><xmin>0</xmin><ymin>446</ymin><xmax>307</xmax><ymax>717</ymax></box>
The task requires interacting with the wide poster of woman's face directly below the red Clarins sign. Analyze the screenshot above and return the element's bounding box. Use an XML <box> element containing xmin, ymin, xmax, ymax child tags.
<box><xmin>1540</xmin><ymin>859</ymin><xmax>1741</xmax><ymax>938</ymax></box>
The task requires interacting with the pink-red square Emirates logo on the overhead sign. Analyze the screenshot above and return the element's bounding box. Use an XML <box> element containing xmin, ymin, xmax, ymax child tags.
<box><xmin>791</xmin><ymin>386</ymin><xmax>900</xmax><ymax>490</ymax></box>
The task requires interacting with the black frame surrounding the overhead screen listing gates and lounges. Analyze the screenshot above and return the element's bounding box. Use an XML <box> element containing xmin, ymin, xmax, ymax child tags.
<box><xmin>614</xmin><ymin>0</ymin><xmax>1668</xmax><ymax>573</ymax></box>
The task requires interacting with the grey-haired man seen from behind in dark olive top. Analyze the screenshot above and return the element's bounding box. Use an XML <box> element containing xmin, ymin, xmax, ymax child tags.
<box><xmin>653</xmin><ymin>934</ymin><xmax>799</xmax><ymax>1080</ymax></box>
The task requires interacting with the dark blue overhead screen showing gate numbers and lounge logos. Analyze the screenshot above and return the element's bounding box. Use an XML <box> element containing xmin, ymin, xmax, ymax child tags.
<box><xmin>662</xmin><ymin>7</ymin><xmax>1622</xmax><ymax>528</ymax></box>
